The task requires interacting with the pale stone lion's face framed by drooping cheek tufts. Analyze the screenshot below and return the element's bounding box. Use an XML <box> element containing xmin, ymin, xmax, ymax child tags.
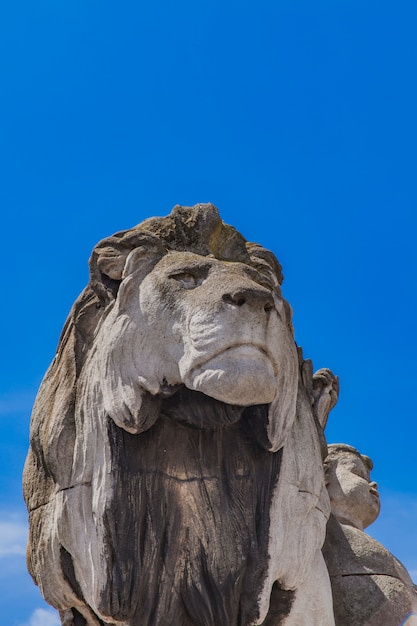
<box><xmin>94</xmin><ymin>206</ymin><xmax>297</xmax><ymax>450</ymax></box>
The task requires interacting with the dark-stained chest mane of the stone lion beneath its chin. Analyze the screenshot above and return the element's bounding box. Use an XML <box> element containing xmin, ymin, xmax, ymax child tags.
<box><xmin>102</xmin><ymin>416</ymin><xmax>280</xmax><ymax>624</ymax></box>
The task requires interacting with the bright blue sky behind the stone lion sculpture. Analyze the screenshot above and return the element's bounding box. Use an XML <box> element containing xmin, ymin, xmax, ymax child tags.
<box><xmin>0</xmin><ymin>0</ymin><xmax>417</xmax><ymax>626</ymax></box>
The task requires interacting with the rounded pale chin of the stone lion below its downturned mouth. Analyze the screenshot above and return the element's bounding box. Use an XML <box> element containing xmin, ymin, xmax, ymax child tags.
<box><xmin>184</xmin><ymin>345</ymin><xmax>276</xmax><ymax>406</ymax></box>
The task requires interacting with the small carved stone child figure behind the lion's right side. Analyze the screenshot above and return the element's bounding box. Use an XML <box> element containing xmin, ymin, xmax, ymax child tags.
<box><xmin>323</xmin><ymin>444</ymin><xmax>417</xmax><ymax>626</ymax></box>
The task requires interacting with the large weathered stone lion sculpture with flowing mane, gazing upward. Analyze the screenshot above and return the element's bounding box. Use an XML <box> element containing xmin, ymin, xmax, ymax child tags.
<box><xmin>24</xmin><ymin>204</ymin><xmax>334</xmax><ymax>626</ymax></box>
